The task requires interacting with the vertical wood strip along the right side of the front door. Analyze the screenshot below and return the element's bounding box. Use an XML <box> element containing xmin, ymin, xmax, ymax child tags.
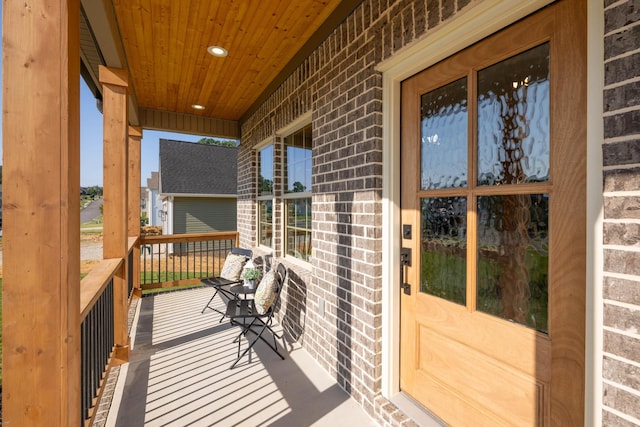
<box><xmin>549</xmin><ymin>0</ymin><xmax>588</xmax><ymax>425</ymax></box>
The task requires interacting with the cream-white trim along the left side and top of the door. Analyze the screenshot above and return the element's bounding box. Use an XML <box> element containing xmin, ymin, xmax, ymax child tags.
<box><xmin>376</xmin><ymin>0</ymin><xmax>568</xmax><ymax>409</ymax></box>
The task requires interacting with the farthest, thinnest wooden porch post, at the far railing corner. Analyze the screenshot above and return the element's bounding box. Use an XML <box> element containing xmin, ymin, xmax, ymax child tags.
<box><xmin>128</xmin><ymin>126</ymin><xmax>142</xmax><ymax>297</ymax></box>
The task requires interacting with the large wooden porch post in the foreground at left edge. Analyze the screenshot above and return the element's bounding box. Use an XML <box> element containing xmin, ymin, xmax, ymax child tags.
<box><xmin>2</xmin><ymin>0</ymin><xmax>81</xmax><ymax>426</ymax></box>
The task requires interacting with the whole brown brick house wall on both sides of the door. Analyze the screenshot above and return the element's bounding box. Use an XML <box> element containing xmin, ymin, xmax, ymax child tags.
<box><xmin>238</xmin><ymin>0</ymin><xmax>640</xmax><ymax>425</ymax></box>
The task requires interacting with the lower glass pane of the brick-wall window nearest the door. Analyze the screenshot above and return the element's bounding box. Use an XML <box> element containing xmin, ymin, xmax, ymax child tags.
<box><xmin>286</xmin><ymin>198</ymin><xmax>311</xmax><ymax>261</ymax></box>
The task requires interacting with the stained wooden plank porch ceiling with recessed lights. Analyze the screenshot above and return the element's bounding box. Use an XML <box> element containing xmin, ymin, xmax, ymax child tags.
<box><xmin>113</xmin><ymin>0</ymin><xmax>348</xmax><ymax>120</ymax></box>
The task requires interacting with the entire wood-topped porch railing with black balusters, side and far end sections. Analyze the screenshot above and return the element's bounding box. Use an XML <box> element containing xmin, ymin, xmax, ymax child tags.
<box><xmin>80</xmin><ymin>231</ymin><xmax>239</xmax><ymax>425</ymax></box>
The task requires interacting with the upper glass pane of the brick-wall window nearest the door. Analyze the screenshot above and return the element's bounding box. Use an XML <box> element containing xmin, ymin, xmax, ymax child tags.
<box><xmin>284</xmin><ymin>125</ymin><xmax>312</xmax><ymax>193</ymax></box>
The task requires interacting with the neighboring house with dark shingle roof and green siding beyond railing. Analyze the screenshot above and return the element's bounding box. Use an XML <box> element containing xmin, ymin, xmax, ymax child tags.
<box><xmin>159</xmin><ymin>139</ymin><xmax>238</xmax><ymax>234</ymax></box>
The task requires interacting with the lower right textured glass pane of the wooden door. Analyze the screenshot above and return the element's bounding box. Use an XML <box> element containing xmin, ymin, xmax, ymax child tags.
<box><xmin>477</xmin><ymin>194</ymin><xmax>549</xmax><ymax>332</ymax></box>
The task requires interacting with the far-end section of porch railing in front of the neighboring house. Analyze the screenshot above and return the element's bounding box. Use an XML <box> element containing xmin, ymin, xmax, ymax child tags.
<box><xmin>140</xmin><ymin>231</ymin><xmax>238</xmax><ymax>290</ymax></box>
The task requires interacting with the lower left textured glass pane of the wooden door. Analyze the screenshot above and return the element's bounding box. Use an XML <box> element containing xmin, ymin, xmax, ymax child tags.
<box><xmin>420</xmin><ymin>197</ymin><xmax>467</xmax><ymax>305</ymax></box>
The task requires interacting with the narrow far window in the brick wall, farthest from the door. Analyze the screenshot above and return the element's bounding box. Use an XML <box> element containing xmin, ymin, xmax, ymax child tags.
<box><xmin>258</xmin><ymin>145</ymin><xmax>273</xmax><ymax>247</ymax></box>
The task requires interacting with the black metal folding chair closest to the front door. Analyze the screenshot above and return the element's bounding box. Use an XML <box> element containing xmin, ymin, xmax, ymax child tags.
<box><xmin>225</xmin><ymin>263</ymin><xmax>287</xmax><ymax>369</ymax></box>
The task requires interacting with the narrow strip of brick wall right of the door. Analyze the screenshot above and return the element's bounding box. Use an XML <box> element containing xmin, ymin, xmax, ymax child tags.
<box><xmin>602</xmin><ymin>0</ymin><xmax>640</xmax><ymax>426</ymax></box>
